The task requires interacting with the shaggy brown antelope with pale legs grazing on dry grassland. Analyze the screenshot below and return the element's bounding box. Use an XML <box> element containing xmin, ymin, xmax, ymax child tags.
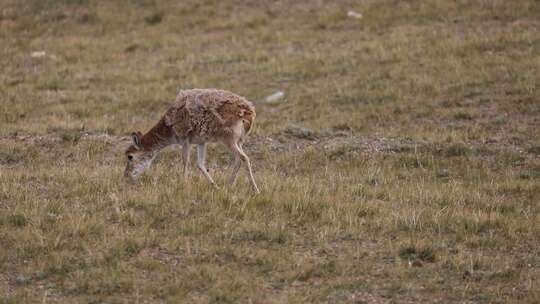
<box><xmin>124</xmin><ymin>89</ymin><xmax>259</xmax><ymax>193</ymax></box>
